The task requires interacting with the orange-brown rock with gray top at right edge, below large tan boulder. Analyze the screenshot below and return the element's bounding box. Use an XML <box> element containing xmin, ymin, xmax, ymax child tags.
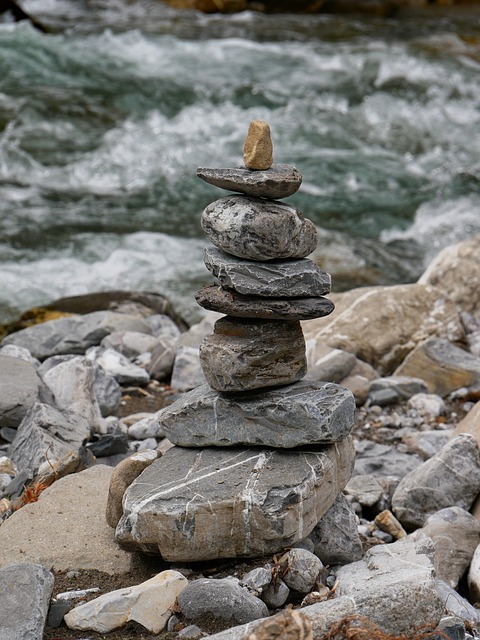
<box><xmin>395</xmin><ymin>338</ymin><xmax>480</xmax><ymax>396</ymax></box>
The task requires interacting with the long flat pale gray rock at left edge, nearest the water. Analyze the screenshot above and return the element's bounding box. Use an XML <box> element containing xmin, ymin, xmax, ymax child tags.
<box><xmin>1</xmin><ymin>311</ymin><xmax>150</xmax><ymax>360</ymax></box>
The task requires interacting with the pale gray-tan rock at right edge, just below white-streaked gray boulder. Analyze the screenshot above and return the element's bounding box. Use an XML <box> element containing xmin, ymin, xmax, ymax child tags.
<box><xmin>412</xmin><ymin>507</ymin><xmax>480</xmax><ymax>589</ymax></box>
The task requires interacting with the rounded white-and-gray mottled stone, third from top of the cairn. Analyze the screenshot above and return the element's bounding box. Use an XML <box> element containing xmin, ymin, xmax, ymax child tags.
<box><xmin>202</xmin><ymin>195</ymin><xmax>317</xmax><ymax>261</ymax></box>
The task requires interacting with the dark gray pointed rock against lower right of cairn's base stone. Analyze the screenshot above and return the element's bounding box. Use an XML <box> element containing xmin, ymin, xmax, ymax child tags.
<box><xmin>310</xmin><ymin>493</ymin><xmax>363</xmax><ymax>565</ymax></box>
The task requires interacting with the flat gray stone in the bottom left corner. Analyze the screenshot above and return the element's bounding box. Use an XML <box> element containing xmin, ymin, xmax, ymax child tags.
<box><xmin>0</xmin><ymin>562</ymin><xmax>54</xmax><ymax>640</ymax></box>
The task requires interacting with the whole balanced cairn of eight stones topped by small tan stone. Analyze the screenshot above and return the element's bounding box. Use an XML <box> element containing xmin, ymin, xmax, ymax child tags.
<box><xmin>116</xmin><ymin>121</ymin><xmax>355</xmax><ymax>561</ymax></box>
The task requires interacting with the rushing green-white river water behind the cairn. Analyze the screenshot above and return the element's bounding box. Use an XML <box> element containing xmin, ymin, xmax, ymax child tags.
<box><xmin>0</xmin><ymin>0</ymin><xmax>480</xmax><ymax>321</ymax></box>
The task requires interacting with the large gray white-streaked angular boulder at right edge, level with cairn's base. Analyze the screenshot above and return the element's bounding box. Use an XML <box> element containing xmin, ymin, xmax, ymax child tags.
<box><xmin>392</xmin><ymin>433</ymin><xmax>480</xmax><ymax>528</ymax></box>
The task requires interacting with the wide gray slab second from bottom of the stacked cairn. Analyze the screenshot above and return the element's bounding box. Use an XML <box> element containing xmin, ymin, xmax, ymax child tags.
<box><xmin>158</xmin><ymin>382</ymin><xmax>355</xmax><ymax>448</ymax></box>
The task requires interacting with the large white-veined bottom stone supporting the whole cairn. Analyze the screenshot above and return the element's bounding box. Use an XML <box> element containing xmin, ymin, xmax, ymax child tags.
<box><xmin>116</xmin><ymin>438</ymin><xmax>354</xmax><ymax>562</ymax></box>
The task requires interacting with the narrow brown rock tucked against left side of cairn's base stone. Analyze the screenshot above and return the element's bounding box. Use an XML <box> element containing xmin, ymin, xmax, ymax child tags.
<box><xmin>105</xmin><ymin>449</ymin><xmax>159</xmax><ymax>529</ymax></box>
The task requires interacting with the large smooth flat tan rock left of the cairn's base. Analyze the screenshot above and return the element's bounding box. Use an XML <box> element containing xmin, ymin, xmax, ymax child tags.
<box><xmin>0</xmin><ymin>465</ymin><xmax>131</xmax><ymax>575</ymax></box>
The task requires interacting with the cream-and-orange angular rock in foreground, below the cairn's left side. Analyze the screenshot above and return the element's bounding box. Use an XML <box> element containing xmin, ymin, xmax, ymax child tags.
<box><xmin>65</xmin><ymin>570</ymin><xmax>188</xmax><ymax>633</ymax></box>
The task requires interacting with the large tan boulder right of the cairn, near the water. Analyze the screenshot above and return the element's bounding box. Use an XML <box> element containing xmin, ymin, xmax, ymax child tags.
<box><xmin>309</xmin><ymin>284</ymin><xmax>464</xmax><ymax>377</ymax></box>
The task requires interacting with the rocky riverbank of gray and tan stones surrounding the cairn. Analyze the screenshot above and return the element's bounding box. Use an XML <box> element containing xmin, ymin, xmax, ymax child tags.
<box><xmin>0</xmin><ymin>237</ymin><xmax>480</xmax><ymax>640</ymax></box>
